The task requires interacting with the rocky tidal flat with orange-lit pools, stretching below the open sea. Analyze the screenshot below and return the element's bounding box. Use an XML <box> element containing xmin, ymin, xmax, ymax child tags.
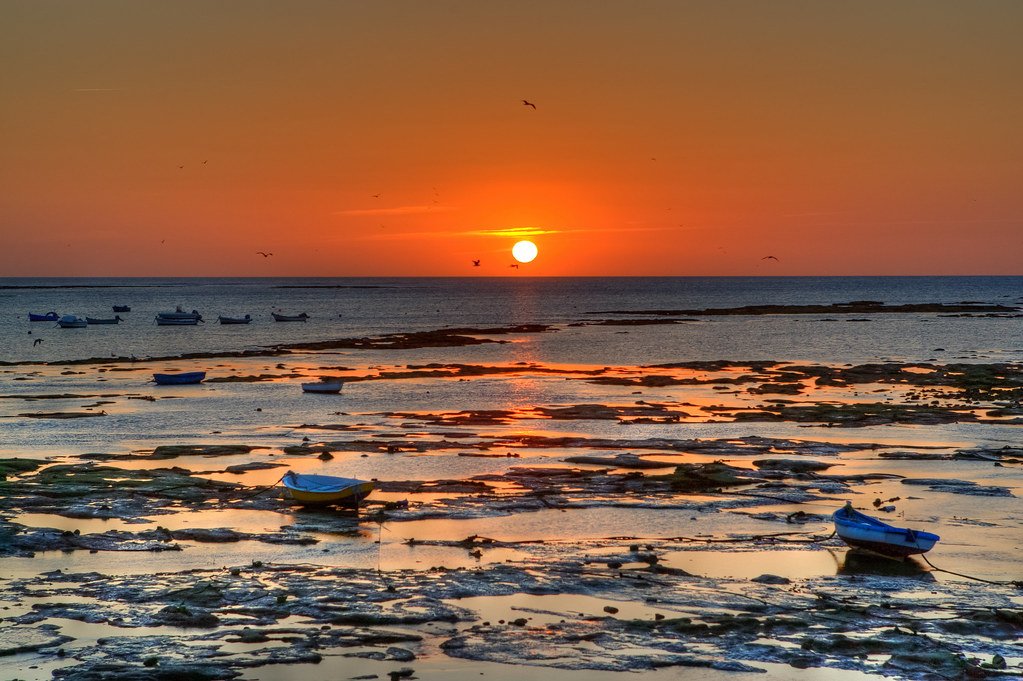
<box><xmin>0</xmin><ymin>284</ymin><xmax>1023</xmax><ymax>681</ymax></box>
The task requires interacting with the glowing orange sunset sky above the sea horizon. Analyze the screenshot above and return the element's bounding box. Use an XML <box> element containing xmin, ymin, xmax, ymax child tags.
<box><xmin>0</xmin><ymin>0</ymin><xmax>1023</xmax><ymax>276</ymax></box>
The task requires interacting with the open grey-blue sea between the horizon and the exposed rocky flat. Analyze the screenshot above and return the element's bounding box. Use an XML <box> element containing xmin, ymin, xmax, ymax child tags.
<box><xmin>0</xmin><ymin>277</ymin><xmax>1023</xmax><ymax>364</ymax></box>
